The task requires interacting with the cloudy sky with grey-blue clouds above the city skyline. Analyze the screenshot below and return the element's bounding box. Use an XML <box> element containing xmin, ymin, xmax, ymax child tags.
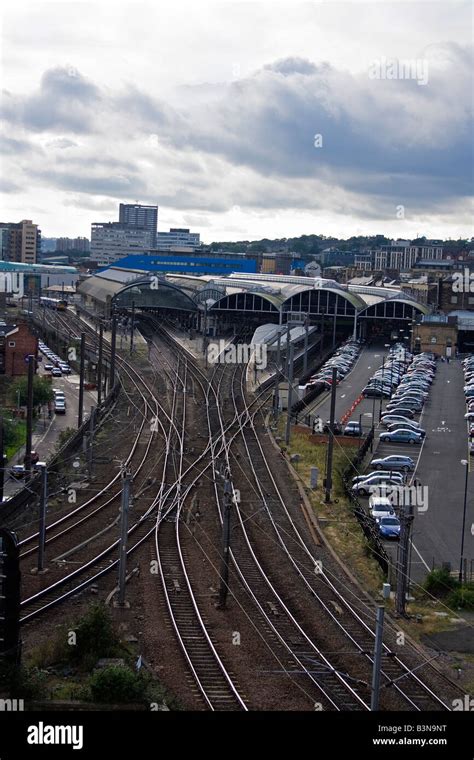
<box><xmin>0</xmin><ymin>0</ymin><xmax>474</xmax><ymax>242</ymax></box>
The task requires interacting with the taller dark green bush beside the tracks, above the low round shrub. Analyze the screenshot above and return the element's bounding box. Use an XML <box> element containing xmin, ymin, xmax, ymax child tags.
<box><xmin>68</xmin><ymin>604</ymin><xmax>119</xmax><ymax>668</ymax></box>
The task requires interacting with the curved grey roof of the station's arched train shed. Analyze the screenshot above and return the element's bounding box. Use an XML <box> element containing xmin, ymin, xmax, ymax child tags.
<box><xmin>78</xmin><ymin>265</ymin><xmax>429</xmax><ymax>319</ymax></box>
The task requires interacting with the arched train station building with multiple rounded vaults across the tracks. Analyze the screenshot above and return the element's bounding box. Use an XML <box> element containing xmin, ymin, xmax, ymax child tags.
<box><xmin>78</xmin><ymin>265</ymin><xmax>428</xmax><ymax>342</ymax></box>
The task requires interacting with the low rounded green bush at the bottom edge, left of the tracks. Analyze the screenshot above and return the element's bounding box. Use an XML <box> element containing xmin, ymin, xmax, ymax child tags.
<box><xmin>89</xmin><ymin>665</ymin><xmax>148</xmax><ymax>704</ymax></box>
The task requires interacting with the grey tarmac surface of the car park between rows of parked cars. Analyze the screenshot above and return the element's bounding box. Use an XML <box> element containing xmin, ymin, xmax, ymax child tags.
<box><xmin>304</xmin><ymin>346</ymin><xmax>474</xmax><ymax>582</ymax></box>
